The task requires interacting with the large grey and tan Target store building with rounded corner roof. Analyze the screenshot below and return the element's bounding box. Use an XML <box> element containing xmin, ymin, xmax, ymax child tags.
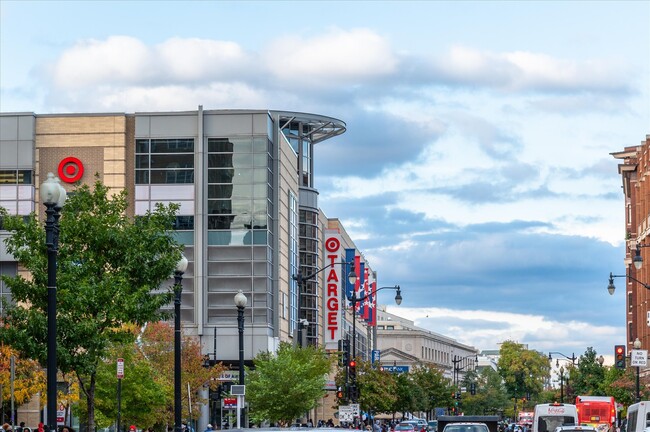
<box><xmin>0</xmin><ymin>106</ymin><xmax>372</xmax><ymax>422</ymax></box>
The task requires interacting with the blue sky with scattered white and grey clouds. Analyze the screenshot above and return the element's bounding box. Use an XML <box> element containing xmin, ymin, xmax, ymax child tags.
<box><xmin>0</xmin><ymin>0</ymin><xmax>650</xmax><ymax>364</ymax></box>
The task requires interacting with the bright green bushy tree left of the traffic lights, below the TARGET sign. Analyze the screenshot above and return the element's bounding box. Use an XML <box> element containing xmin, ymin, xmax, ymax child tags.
<box><xmin>246</xmin><ymin>342</ymin><xmax>332</xmax><ymax>425</ymax></box>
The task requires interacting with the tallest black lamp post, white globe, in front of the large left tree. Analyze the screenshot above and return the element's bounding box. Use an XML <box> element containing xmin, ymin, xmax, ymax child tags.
<box><xmin>40</xmin><ymin>173</ymin><xmax>66</xmax><ymax>431</ymax></box>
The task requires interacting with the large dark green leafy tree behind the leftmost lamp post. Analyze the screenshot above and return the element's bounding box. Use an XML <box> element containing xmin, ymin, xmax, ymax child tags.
<box><xmin>0</xmin><ymin>180</ymin><xmax>182</xmax><ymax>432</ymax></box>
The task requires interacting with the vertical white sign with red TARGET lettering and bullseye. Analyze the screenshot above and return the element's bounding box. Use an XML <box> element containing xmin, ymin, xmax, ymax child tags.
<box><xmin>324</xmin><ymin>229</ymin><xmax>341</xmax><ymax>349</ymax></box>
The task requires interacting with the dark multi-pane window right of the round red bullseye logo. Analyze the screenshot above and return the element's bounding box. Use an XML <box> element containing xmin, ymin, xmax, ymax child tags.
<box><xmin>135</xmin><ymin>138</ymin><xmax>194</xmax><ymax>184</ymax></box>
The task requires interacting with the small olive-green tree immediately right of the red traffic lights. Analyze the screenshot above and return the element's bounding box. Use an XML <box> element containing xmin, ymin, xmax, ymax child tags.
<box><xmin>357</xmin><ymin>361</ymin><xmax>397</xmax><ymax>413</ymax></box>
